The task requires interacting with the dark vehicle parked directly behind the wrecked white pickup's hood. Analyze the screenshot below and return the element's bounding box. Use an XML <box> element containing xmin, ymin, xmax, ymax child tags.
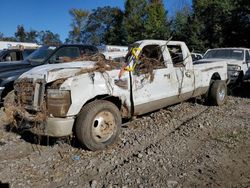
<box><xmin>0</xmin><ymin>44</ymin><xmax>98</xmax><ymax>102</ymax></box>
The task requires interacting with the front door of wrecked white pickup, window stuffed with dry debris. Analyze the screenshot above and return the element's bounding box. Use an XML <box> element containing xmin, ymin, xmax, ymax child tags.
<box><xmin>132</xmin><ymin>45</ymin><xmax>178</xmax><ymax>114</ymax></box>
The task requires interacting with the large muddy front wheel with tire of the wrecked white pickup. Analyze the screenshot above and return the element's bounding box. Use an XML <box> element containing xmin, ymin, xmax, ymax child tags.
<box><xmin>75</xmin><ymin>100</ymin><xmax>122</xmax><ymax>151</ymax></box>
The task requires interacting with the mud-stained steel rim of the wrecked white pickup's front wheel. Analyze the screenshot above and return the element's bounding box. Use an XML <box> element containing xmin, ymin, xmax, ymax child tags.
<box><xmin>92</xmin><ymin>111</ymin><xmax>116</xmax><ymax>143</ymax></box>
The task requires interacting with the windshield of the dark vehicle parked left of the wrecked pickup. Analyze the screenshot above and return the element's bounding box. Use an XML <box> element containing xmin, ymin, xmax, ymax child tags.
<box><xmin>25</xmin><ymin>46</ymin><xmax>55</xmax><ymax>63</ymax></box>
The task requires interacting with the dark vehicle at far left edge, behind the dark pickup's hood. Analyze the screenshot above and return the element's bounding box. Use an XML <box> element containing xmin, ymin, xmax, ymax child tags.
<box><xmin>0</xmin><ymin>47</ymin><xmax>37</xmax><ymax>62</ymax></box>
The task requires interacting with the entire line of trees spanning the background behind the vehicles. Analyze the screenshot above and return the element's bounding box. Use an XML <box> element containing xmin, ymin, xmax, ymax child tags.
<box><xmin>0</xmin><ymin>0</ymin><xmax>250</xmax><ymax>51</ymax></box>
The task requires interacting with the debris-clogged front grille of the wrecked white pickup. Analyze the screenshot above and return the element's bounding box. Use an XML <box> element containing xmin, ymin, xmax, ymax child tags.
<box><xmin>14</xmin><ymin>78</ymin><xmax>45</xmax><ymax>111</ymax></box>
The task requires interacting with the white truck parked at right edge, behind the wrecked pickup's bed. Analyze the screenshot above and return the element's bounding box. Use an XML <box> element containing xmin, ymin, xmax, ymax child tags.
<box><xmin>196</xmin><ymin>48</ymin><xmax>250</xmax><ymax>84</ymax></box>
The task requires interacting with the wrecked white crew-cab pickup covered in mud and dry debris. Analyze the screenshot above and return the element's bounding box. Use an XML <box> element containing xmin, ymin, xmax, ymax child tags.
<box><xmin>6</xmin><ymin>40</ymin><xmax>227</xmax><ymax>150</ymax></box>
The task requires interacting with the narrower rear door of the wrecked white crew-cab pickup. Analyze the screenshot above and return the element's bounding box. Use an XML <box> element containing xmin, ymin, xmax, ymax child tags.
<box><xmin>168</xmin><ymin>44</ymin><xmax>195</xmax><ymax>101</ymax></box>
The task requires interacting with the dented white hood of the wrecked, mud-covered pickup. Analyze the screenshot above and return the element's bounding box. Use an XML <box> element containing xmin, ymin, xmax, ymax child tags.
<box><xmin>20</xmin><ymin>61</ymin><xmax>96</xmax><ymax>83</ymax></box>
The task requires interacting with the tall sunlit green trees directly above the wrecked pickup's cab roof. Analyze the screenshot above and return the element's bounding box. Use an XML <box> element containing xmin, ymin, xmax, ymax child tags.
<box><xmin>123</xmin><ymin>0</ymin><xmax>170</xmax><ymax>44</ymax></box>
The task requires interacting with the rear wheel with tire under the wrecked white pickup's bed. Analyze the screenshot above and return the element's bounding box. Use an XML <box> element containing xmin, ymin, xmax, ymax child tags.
<box><xmin>208</xmin><ymin>80</ymin><xmax>227</xmax><ymax>106</ymax></box>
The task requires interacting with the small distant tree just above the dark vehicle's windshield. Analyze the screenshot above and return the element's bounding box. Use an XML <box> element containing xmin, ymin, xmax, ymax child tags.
<box><xmin>38</xmin><ymin>30</ymin><xmax>62</xmax><ymax>45</ymax></box>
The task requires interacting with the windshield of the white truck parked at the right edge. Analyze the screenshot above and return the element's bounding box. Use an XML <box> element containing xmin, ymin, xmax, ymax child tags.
<box><xmin>203</xmin><ymin>49</ymin><xmax>244</xmax><ymax>60</ymax></box>
